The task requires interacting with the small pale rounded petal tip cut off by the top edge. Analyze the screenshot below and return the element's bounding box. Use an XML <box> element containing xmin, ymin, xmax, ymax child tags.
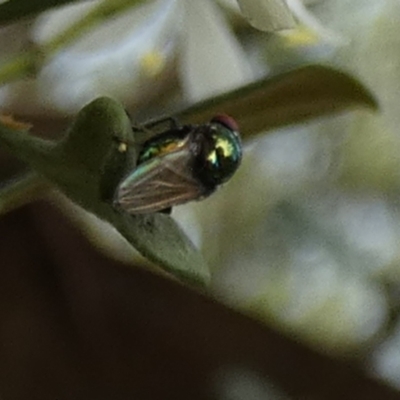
<box><xmin>238</xmin><ymin>0</ymin><xmax>296</xmax><ymax>32</ymax></box>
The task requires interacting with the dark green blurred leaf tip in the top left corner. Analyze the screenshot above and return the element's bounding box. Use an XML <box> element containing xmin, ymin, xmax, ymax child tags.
<box><xmin>0</xmin><ymin>0</ymin><xmax>82</xmax><ymax>24</ymax></box>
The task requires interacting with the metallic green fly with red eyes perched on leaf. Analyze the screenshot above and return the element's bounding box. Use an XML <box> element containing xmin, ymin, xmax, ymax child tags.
<box><xmin>114</xmin><ymin>115</ymin><xmax>242</xmax><ymax>214</ymax></box>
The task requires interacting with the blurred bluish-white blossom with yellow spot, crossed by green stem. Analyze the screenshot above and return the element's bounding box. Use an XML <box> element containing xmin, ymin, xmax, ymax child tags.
<box><xmin>3</xmin><ymin>0</ymin><xmax>182</xmax><ymax>113</ymax></box>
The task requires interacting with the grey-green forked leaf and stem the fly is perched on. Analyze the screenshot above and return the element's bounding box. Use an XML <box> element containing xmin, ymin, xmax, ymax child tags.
<box><xmin>0</xmin><ymin>97</ymin><xmax>209</xmax><ymax>285</ymax></box>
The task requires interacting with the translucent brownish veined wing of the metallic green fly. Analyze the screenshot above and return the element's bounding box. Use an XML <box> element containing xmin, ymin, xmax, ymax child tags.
<box><xmin>116</xmin><ymin>146</ymin><xmax>206</xmax><ymax>214</ymax></box>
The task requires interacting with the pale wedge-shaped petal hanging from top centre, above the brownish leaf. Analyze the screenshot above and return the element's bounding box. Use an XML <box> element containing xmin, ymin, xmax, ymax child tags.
<box><xmin>181</xmin><ymin>0</ymin><xmax>252</xmax><ymax>102</ymax></box>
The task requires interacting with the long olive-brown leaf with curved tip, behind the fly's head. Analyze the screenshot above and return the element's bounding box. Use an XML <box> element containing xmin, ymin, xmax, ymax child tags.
<box><xmin>176</xmin><ymin>65</ymin><xmax>377</xmax><ymax>138</ymax></box>
